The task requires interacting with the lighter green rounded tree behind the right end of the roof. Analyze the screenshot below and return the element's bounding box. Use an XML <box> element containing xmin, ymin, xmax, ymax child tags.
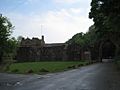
<box><xmin>66</xmin><ymin>25</ymin><xmax>99</xmax><ymax>48</ymax></box>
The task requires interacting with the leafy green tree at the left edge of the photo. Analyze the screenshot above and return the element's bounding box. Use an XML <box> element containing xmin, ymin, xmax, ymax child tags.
<box><xmin>0</xmin><ymin>15</ymin><xmax>13</xmax><ymax>63</ymax></box>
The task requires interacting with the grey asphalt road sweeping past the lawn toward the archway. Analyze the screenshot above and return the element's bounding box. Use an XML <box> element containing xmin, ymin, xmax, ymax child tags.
<box><xmin>0</xmin><ymin>63</ymin><xmax>120</xmax><ymax>90</ymax></box>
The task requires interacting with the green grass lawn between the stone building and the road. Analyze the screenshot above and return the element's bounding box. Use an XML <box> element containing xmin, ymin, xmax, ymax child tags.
<box><xmin>7</xmin><ymin>61</ymin><xmax>89</xmax><ymax>74</ymax></box>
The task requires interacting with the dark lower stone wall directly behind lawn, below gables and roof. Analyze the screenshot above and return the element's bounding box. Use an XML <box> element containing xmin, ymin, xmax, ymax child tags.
<box><xmin>16</xmin><ymin>45</ymin><xmax>66</xmax><ymax>62</ymax></box>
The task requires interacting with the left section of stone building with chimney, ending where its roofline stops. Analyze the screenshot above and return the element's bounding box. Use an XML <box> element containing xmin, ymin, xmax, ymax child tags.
<box><xmin>16</xmin><ymin>36</ymin><xmax>67</xmax><ymax>62</ymax></box>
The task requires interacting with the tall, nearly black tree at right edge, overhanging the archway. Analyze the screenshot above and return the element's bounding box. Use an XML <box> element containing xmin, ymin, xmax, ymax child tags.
<box><xmin>89</xmin><ymin>0</ymin><xmax>120</xmax><ymax>58</ymax></box>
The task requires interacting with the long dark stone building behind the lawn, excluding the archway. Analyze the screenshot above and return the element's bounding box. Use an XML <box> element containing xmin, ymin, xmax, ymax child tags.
<box><xmin>16</xmin><ymin>36</ymin><xmax>90</xmax><ymax>62</ymax></box>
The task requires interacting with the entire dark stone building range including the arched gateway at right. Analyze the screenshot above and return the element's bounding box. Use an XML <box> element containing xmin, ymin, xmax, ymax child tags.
<box><xmin>16</xmin><ymin>33</ymin><xmax>119</xmax><ymax>62</ymax></box>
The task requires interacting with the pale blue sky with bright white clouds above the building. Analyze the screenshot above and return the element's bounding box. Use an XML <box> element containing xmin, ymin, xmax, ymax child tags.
<box><xmin>0</xmin><ymin>0</ymin><xmax>93</xmax><ymax>43</ymax></box>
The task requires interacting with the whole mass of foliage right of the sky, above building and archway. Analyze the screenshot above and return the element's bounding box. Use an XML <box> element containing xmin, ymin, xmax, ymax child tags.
<box><xmin>67</xmin><ymin>0</ymin><xmax>120</xmax><ymax>56</ymax></box>
